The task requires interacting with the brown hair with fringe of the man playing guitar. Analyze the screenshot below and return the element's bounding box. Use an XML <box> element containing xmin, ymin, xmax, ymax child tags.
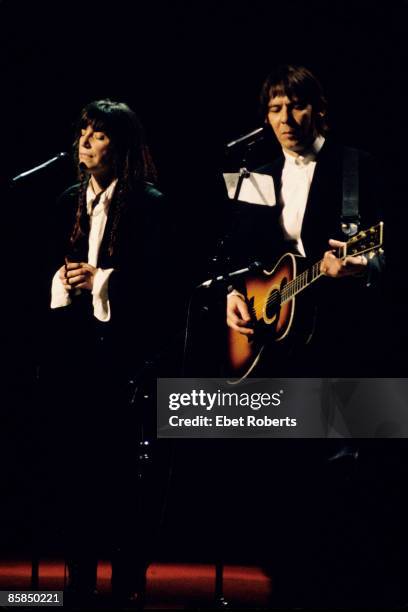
<box><xmin>260</xmin><ymin>64</ymin><xmax>328</xmax><ymax>134</ymax></box>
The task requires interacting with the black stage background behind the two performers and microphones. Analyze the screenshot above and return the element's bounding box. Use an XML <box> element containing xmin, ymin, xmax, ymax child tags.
<box><xmin>0</xmin><ymin>0</ymin><xmax>408</xmax><ymax>608</ymax></box>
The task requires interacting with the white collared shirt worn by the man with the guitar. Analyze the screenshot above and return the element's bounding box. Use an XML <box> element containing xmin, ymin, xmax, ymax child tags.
<box><xmin>280</xmin><ymin>136</ymin><xmax>325</xmax><ymax>257</ymax></box>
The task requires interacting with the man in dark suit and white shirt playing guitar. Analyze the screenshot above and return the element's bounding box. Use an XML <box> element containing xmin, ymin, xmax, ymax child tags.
<box><xmin>220</xmin><ymin>65</ymin><xmax>396</xmax><ymax>607</ymax></box>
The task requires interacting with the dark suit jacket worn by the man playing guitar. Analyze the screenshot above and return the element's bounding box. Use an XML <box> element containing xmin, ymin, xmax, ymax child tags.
<box><xmin>225</xmin><ymin>139</ymin><xmax>384</xmax><ymax>376</ymax></box>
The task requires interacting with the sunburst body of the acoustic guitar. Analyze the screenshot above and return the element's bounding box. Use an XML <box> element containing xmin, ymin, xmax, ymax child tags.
<box><xmin>227</xmin><ymin>253</ymin><xmax>296</xmax><ymax>382</ymax></box>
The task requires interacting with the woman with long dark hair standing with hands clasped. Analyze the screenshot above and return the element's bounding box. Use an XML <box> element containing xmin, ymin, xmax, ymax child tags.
<box><xmin>47</xmin><ymin>100</ymin><xmax>163</xmax><ymax>600</ymax></box>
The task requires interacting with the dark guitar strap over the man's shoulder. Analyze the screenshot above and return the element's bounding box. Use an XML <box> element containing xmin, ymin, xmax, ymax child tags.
<box><xmin>341</xmin><ymin>147</ymin><xmax>360</xmax><ymax>238</ymax></box>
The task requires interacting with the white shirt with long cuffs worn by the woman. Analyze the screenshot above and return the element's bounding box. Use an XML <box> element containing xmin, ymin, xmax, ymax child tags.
<box><xmin>51</xmin><ymin>179</ymin><xmax>117</xmax><ymax>323</ymax></box>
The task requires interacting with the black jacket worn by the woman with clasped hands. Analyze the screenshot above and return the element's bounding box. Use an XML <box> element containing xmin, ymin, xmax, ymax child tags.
<box><xmin>50</xmin><ymin>179</ymin><xmax>169</xmax><ymax>376</ymax></box>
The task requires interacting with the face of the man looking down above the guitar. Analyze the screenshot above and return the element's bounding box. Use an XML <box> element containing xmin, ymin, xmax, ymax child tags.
<box><xmin>268</xmin><ymin>95</ymin><xmax>317</xmax><ymax>155</ymax></box>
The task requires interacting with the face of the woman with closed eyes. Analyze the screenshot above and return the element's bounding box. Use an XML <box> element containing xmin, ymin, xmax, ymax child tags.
<box><xmin>78</xmin><ymin>125</ymin><xmax>112</xmax><ymax>176</ymax></box>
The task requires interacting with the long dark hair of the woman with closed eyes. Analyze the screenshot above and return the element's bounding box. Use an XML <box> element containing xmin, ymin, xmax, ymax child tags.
<box><xmin>70</xmin><ymin>99</ymin><xmax>157</xmax><ymax>255</ymax></box>
